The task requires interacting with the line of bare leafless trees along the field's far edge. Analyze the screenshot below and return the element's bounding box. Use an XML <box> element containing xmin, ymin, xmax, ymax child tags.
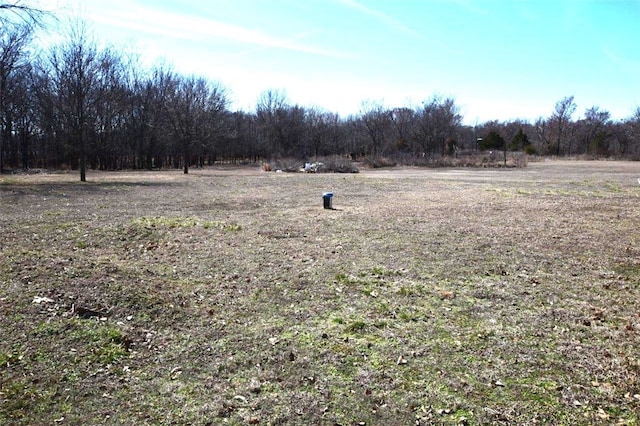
<box><xmin>0</xmin><ymin>4</ymin><xmax>640</xmax><ymax>181</ymax></box>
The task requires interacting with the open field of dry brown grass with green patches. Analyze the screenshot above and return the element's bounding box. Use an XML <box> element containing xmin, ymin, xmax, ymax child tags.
<box><xmin>0</xmin><ymin>161</ymin><xmax>640</xmax><ymax>425</ymax></box>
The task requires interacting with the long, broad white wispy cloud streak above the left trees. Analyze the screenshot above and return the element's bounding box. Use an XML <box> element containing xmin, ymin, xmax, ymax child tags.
<box><xmin>85</xmin><ymin>4</ymin><xmax>349</xmax><ymax>58</ymax></box>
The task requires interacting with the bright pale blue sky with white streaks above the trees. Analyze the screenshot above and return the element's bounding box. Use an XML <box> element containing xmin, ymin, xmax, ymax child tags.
<box><xmin>45</xmin><ymin>0</ymin><xmax>640</xmax><ymax>125</ymax></box>
